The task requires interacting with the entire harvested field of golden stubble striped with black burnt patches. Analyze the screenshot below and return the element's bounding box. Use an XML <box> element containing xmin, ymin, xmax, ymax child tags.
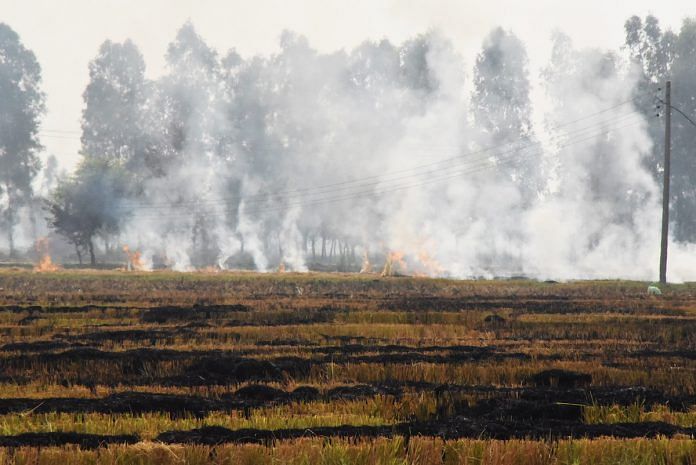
<box><xmin>0</xmin><ymin>270</ymin><xmax>696</xmax><ymax>465</ymax></box>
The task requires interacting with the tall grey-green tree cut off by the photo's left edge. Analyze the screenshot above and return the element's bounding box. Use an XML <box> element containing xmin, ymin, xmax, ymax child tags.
<box><xmin>0</xmin><ymin>23</ymin><xmax>45</xmax><ymax>256</ymax></box>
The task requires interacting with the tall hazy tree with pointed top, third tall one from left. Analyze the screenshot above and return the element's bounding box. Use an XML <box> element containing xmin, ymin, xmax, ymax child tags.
<box><xmin>150</xmin><ymin>22</ymin><xmax>231</xmax><ymax>266</ymax></box>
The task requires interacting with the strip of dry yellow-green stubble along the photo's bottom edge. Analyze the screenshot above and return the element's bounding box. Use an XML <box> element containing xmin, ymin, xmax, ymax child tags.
<box><xmin>0</xmin><ymin>438</ymin><xmax>696</xmax><ymax>465</ymax></box>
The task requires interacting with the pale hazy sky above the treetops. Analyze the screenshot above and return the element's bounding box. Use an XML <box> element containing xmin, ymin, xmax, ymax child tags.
<box><xmin>0</xmin><ymin>0</ymin><xmax>696</xmax><ymax>170</ymax></box>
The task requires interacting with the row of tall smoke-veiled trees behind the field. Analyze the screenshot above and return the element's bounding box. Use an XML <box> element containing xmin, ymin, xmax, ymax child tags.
<box><xmin>0</xmin><ymin>16</ymin><xmax>696</xmax><ymax>267</ymax></box>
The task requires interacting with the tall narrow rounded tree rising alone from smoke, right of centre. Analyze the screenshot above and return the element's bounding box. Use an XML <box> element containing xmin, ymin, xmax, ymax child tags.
<box><xmin>472</xmin><ymin>28</ymin><xmax>540</xmax><ymax>198</ymax></box>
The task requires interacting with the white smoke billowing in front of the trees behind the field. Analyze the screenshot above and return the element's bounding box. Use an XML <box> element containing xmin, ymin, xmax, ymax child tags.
<box><xmin>66</xmin><ymin>25</ymin><xmax>696</xmax><ymax>280</ymax></box>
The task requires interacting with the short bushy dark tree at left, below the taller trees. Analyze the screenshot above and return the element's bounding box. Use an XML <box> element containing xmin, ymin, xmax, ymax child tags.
<box><xmin>48</xmin><ymin>158</ymin><xmax>128</xmax><ymax>265</ymax></box>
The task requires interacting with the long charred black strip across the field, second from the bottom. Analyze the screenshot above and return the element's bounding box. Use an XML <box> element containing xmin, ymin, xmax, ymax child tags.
<box><xmin>0</xmin><ymin>384</ymin><xmax>696</xmax><ymax>421</ymax></box>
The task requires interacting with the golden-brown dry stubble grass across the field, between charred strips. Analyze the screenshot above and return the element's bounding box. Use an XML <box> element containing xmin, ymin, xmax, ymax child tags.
<box><xmin>0</xmin><ymin>270</ymin><xmax>696</xmax><ymax>465</ymax></box>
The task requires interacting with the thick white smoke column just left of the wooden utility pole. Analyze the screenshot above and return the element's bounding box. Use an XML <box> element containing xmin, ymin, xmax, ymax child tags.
<box><xmin>525</xmin><ymin>34</ymin><xmax>660</xmax><ymax>279</ymax></box>
